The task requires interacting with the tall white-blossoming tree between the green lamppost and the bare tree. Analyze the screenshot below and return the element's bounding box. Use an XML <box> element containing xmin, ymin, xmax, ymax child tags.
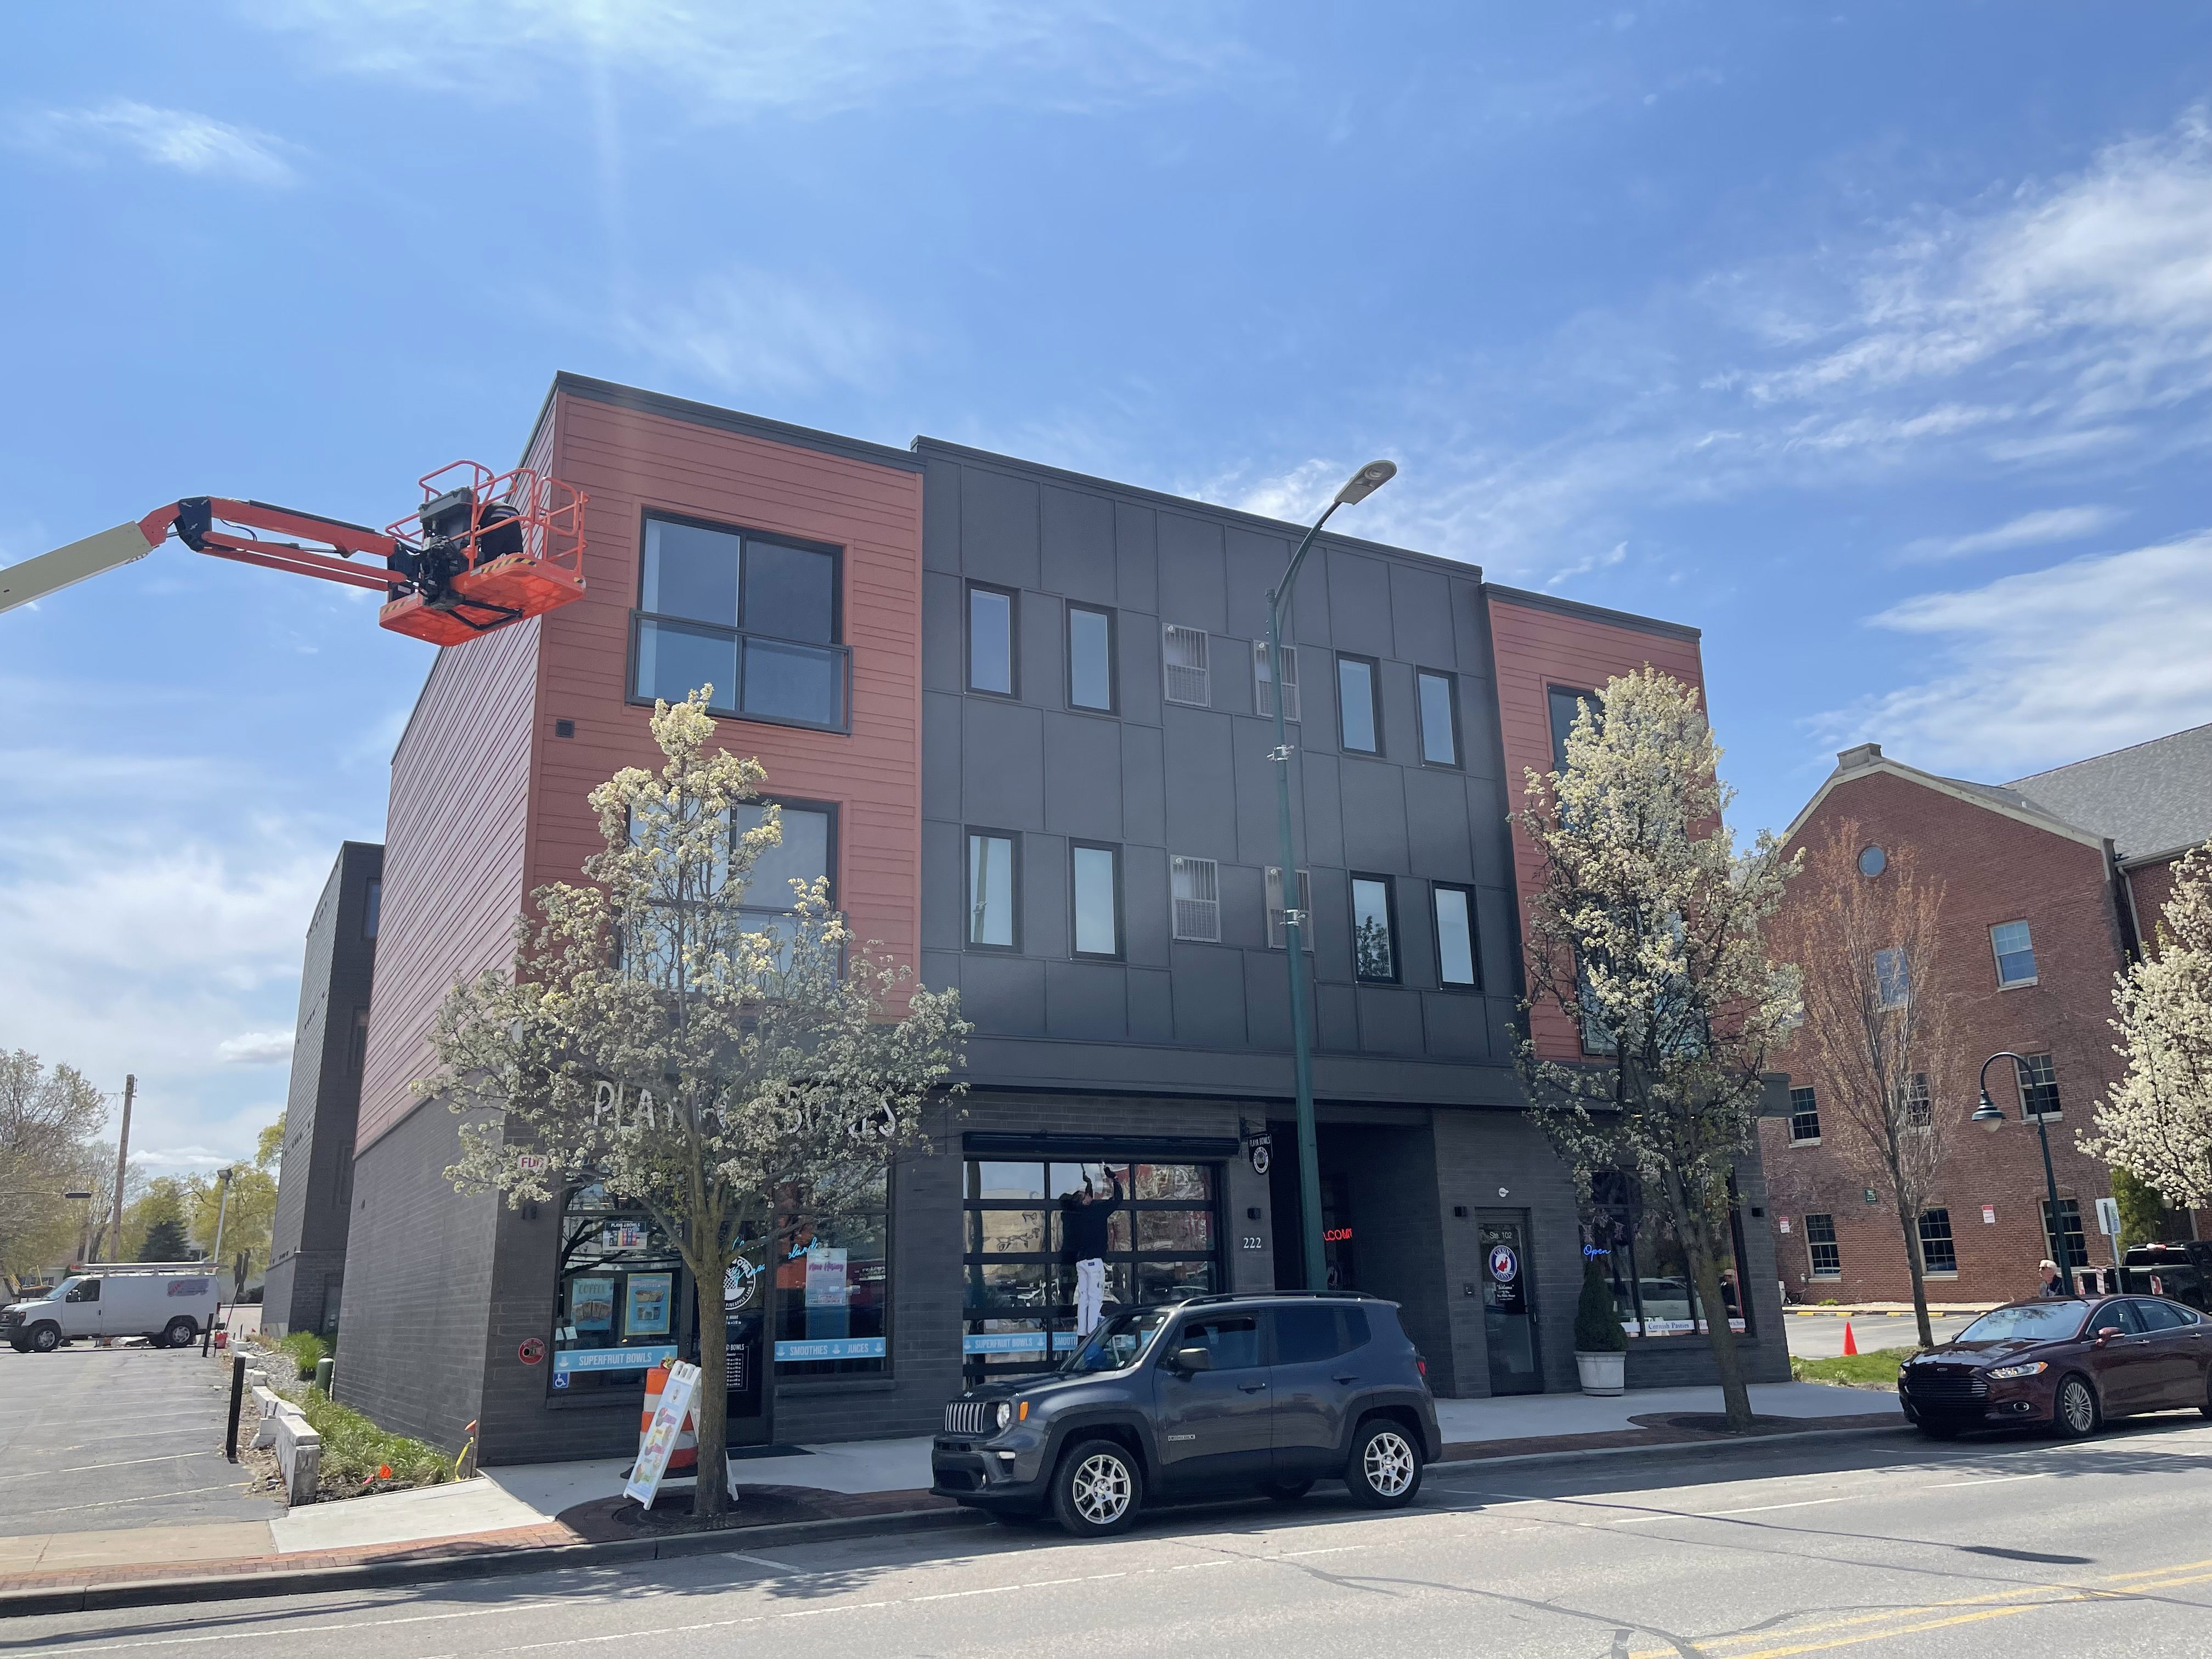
<box><xmin>1520</xmin><ymin>668</ymin><xmax>1801</xmax><ymax>1429</ymax></box>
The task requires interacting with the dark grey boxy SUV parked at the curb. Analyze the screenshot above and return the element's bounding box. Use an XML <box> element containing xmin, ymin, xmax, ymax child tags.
<box><xmin>929</xmin><ymin>1292</ymin><xmax>1442</xmax><ymax>1537</ymax></box>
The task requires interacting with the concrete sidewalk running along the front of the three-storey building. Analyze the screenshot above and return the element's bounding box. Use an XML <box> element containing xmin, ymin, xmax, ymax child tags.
<box><xmin>0</xmin><ymin>1383</ymin><xmax>1905</xmax><ymax>1612</ymax></box>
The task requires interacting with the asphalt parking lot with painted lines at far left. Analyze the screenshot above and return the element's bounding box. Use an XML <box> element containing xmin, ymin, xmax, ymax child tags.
<box><xmin>0</xmin><ymin>1342</ymin><xmax>279</xmax><ymax>1555</ymax></box>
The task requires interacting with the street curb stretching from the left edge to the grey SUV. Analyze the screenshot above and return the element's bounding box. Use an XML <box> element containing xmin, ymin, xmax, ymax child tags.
<box><xmin>0</xmin><ymin>1509</ymin><xmax>989</xmax><ymax>1619</ymax></box>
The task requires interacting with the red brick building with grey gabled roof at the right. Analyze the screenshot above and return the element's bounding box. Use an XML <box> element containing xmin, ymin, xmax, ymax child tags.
<box><xmin>1760</xmin><ymin>725</ymin><xmax>2212</xmax><ymax>1303</ymax></box>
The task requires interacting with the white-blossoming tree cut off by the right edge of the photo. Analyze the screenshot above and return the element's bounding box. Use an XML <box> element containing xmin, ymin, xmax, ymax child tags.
<box><xmin>2081</xmin><ymin>843</ymin><xmax>2212</xmax><ymax>1207</ymax></box>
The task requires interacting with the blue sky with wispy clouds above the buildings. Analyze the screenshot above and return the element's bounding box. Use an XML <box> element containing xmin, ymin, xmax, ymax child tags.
<box><xmin>0</xmin><ymin>0</ymin><xmax>2212</xmax><ymax>1168</ymax></box>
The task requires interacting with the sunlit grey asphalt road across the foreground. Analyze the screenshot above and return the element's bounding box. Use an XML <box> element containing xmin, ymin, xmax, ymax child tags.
<box><xmin>17</xmin><ymin>1415</ymin><xmax>2212</xmax><ymax>1659</ymax></box>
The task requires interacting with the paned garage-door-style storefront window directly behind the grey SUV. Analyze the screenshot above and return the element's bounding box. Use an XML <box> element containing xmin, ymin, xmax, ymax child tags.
<box><xmin>962</xmin><ymin>1159</ymin><xmax>1221</xmax><ymax>1380</ymax></box>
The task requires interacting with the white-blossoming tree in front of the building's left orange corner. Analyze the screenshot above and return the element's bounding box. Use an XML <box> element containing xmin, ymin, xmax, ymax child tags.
<box><xmin>416</xmin><ymin>688</ymin><xmax>969</xmax><ymax>1517</ymax></box>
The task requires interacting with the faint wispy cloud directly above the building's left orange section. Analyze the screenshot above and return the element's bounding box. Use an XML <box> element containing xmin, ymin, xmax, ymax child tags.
<box><xmin>617</xmin><ymin>268</ymin><xmax>907</xmax><ymax>407</ymax></box>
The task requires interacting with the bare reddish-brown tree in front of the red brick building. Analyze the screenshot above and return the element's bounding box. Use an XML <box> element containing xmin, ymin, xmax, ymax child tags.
<box><xmin>1785</xmin><ymin>823</ymin><xmax>1962</xmax><ymax>1347</ymax></box>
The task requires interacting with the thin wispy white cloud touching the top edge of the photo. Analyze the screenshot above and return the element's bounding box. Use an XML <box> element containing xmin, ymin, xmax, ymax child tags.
<box><xmin>239</xmin><ymin>0</ymin><xmax>1256</xmax><ymax>117</ymax></box>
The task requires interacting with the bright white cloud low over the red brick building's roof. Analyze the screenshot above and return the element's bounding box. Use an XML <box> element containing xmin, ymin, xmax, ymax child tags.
<box><xmin>1812</xmin><ymin>531</ymin><xmax>2212</xmax><ymax>778</ymax></box>
